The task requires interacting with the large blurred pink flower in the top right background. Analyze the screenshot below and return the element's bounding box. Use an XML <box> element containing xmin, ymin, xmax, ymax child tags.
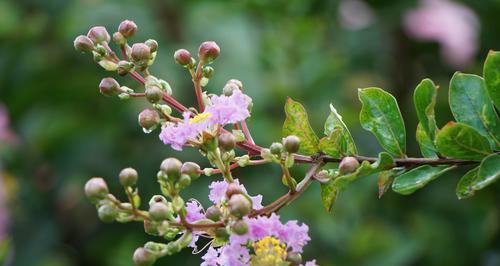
<box><xmin>404</xmin><ymin>0</ymin><xmax>480</xmax><ymax>68</ymax></box>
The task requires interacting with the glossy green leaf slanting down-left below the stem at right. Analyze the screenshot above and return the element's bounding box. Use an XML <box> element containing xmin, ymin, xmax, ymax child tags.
<box><xmin>392</xmin><ymin>165</ymin><xmax>456</xmax><ymax>195</ymax></box>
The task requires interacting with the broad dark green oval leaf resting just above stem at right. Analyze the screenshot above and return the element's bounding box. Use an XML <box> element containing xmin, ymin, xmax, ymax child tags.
<box><xmin>436</xmin><ymin>122</ymin><xmax>492</xmax><ymax>161</ymax></box>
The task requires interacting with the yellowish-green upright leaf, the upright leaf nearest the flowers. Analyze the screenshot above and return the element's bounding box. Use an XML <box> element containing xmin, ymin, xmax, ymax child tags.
<box><xmin>283</xmin><ymin>98</ymin><xmax>319</xmax><ymax>155</ymax></box>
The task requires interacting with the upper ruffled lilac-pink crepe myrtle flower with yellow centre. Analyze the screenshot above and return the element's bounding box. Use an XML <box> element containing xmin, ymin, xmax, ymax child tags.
<box><xmin>160</xmin><ymin>90</ymin><xmax>252</xmax><ymax>151</ymax></box>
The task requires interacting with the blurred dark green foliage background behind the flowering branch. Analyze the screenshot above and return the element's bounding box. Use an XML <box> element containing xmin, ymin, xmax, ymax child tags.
<box><xmin>0</xmin><ymin>0</ymin><xmax>500</xmax><ymax>266</ymax></box>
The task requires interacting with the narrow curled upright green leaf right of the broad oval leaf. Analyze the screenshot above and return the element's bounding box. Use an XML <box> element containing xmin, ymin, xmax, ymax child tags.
<box><xmin>413</xmin><ymin>79</ymin><xmax>437</xmax><ymax>140</ymax></box>
